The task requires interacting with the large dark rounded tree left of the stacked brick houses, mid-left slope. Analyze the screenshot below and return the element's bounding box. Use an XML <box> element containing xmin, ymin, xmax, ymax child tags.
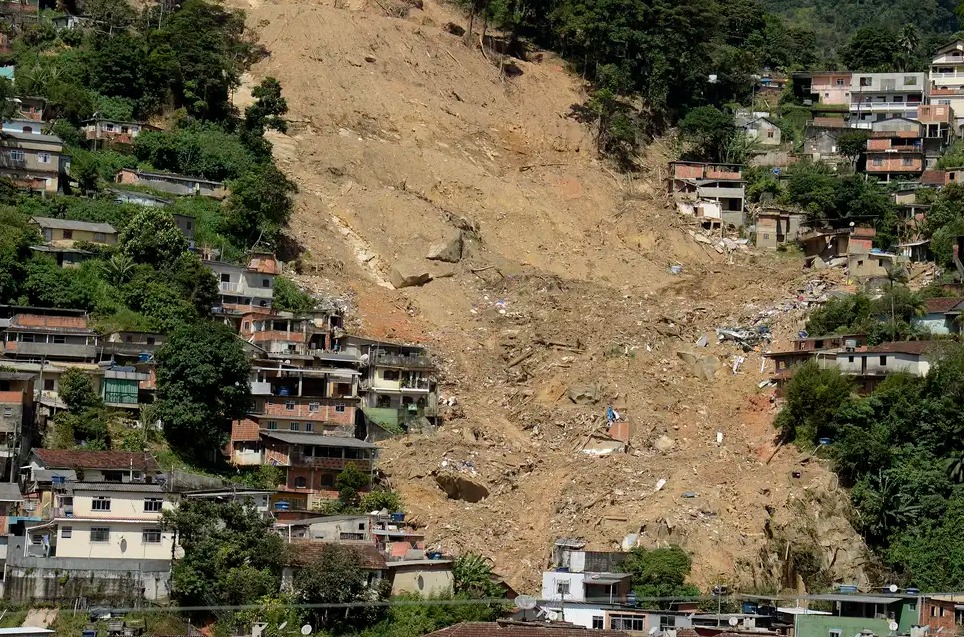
<box><xmin>156</xmin><ymin>323</ymin><xmax>251</xmax><ymax>458</ymax></box>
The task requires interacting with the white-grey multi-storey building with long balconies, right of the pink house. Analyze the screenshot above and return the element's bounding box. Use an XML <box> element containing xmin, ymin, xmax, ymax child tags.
<box><xmin>850</xmin><ymin>73</ymin><xmax>927</xmax><ymax>128</ymax></box>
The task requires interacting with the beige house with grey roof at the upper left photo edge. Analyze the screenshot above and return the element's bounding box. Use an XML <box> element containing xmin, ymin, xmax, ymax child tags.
<box><xmin>0</xmin><ymin>132</ymin><xmax>70</xmax><ymax>194</ymax></box>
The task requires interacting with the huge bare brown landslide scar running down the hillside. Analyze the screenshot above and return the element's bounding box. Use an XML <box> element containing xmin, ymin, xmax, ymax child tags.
<box><xmin>228</xmin><ymin>0</ymin><xmax>864</xmax><ymax>592</ymax></box>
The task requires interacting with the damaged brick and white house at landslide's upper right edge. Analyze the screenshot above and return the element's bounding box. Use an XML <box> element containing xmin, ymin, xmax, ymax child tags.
<box><xmin>668</xmin><ymin>161</ymin><xmax>746</xmax><ymax>228</ymax></box>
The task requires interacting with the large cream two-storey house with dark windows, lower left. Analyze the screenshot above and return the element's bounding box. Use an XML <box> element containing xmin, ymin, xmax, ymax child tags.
<box><xmin>28</xmin><ymin>482</ymin><xmax>174</xmax><ymax>561</ymax></box>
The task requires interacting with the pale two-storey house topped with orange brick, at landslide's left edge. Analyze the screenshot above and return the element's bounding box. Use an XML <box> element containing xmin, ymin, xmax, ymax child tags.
<box><xmin>204</xmin><ymin>253</ymin><xmax>283</xmax><ymax>315</ymax></box>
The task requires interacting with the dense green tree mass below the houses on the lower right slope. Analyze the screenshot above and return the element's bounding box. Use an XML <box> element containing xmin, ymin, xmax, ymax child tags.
<box><xmin>778</xmin><ymin>342</ymin><xmax>964</xmax><ymax>591</ymax></box>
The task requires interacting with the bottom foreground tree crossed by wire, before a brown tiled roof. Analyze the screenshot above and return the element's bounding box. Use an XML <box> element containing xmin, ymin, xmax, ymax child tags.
<box><xmin>294</xmin><ymin>544</ymin><xmax>385</xmax><ymax>634</ymax></box>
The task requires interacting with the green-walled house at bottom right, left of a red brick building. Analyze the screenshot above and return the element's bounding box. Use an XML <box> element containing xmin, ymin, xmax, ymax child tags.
<box><xmin>794</xmin><ymin>593</ymin><xmax>920</xmax><ymax>637</ymax></box>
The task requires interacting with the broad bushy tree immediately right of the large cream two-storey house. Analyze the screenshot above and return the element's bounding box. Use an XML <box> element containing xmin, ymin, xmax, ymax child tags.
<box><xmin>163</xmin><ymin>499</ymin><xmax>284</xmax><ymax>606</ymax></box>
